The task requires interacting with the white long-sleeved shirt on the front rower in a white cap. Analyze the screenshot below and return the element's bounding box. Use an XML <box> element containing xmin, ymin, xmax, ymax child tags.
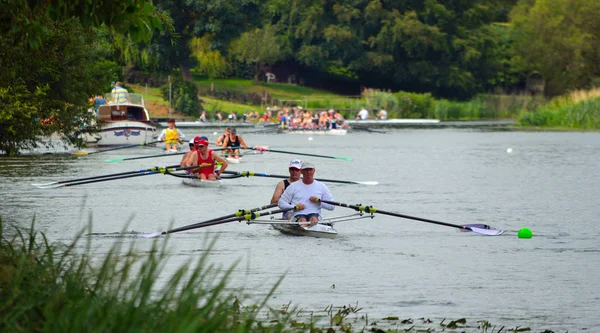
<box><xmin>277</xmin><ymin>180</ymin><xmax>335</xmax><ymax>215</ymax></box>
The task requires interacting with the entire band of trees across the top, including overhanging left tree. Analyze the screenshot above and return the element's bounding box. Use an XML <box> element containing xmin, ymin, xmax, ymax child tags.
<box><xmin>0</xmin><ymin>0</ymin><xmax>600</xmax><ymax>153</ymax></box>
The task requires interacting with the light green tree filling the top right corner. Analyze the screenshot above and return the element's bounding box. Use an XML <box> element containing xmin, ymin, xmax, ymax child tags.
<box><xmin>511</xmin><ymin>0</ymin><xmax>600</xmax><ymax>95</ymax></box>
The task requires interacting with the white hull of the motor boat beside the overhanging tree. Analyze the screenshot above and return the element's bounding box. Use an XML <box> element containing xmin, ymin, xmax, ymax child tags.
<box><xmin>98</xmin><ymin>120</ymin><xmax>157</xmax><ymax>147</ymax></box>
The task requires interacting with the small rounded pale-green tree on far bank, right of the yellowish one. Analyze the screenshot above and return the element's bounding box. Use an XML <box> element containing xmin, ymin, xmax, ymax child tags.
<box><xmin>230</xmin><ymin>25</ymin><xmax>282</xmax><ymax>81</ymax></box>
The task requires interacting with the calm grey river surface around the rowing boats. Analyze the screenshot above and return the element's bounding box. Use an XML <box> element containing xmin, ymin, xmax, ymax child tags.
<box><xmin>0</xmin><ymin>129</ymin><xmax>600</xmax><ymax>332</ymax></box>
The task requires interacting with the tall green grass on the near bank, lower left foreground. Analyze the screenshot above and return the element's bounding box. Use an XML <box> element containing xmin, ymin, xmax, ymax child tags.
<box><xmin>0</xmin><ymin>219</ymin><xmax>289</xmax><ymax>332</ymax></box>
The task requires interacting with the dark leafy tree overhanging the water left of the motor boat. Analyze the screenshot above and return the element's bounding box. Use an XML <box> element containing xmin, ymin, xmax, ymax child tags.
<box><xmin>0</xmin><ymin>0</ymin><xmax>168</xmax><ymax>154</ymax></box>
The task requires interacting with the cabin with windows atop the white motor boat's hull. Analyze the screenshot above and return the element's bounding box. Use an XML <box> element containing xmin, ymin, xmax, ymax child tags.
<box><xmin>98</xmin><ymin>94</ymin><xmax>150</xmax><ymax>121</ymax></box>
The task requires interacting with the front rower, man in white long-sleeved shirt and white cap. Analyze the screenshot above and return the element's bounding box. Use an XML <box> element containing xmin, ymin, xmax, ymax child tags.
<box><xmin>277</xmin><ymin>162</ymin><xmax>335</xmax><ymax>228</ymax></box>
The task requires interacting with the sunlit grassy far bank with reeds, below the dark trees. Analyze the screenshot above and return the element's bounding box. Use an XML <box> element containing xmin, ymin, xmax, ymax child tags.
<box><xmin>129</xmin><ymin>77</ymin><xmax>539</xmax><ymax>120</ymax></box>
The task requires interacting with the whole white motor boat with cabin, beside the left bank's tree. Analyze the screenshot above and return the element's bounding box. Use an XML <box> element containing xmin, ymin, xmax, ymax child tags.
<box><xmin>97</xmin><ymin>94</ymin><xmax>157</xmax><ymax>147</ymax></box>
